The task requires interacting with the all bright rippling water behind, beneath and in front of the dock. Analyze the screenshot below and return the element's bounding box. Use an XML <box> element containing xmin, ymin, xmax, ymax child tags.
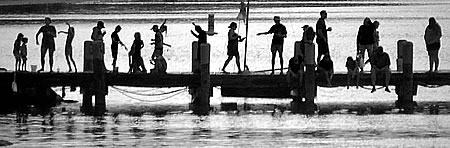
<box><xmin>0</xmin><ymin>0</ymin><xmax>450</xmax><ymax>147</ymax></box>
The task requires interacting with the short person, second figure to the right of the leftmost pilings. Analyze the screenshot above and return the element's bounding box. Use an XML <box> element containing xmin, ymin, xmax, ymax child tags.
<box><xmin>131</xmin><ymin>32</ymin><xmax>147</xmax><ymax>73</ymax></box>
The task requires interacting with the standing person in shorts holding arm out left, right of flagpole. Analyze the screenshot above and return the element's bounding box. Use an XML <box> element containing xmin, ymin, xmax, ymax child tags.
<box><xmin>256</xmin><ymin>16</ymin><xmax>287</xmax><ymax>75</ymax></box>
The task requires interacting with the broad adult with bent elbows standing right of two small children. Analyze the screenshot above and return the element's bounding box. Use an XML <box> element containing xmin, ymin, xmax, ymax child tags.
<box><xmin>36</xmin><ymin>17</ymin><xmax>56</xmax><ymax>72</ymax></box>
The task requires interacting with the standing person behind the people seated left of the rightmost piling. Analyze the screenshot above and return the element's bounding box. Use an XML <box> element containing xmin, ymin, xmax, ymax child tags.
<box><xmin>356</xmin><ymin>17</ymin><xmax>376</xmax><ymax>71</ymax></box>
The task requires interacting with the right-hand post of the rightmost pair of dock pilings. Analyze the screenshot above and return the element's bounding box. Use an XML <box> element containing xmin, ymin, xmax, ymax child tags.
<box><xmin>399</xmin><ymin>42</ymin><xmax>414</xmax><ymax>113</ymax></box>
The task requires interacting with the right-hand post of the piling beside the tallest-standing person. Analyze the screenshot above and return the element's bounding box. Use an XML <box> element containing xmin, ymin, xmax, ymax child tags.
<box><xmin>303</xmin><ymin>44</ymin><xmax>317</xmax><ymax>114</ymax></box>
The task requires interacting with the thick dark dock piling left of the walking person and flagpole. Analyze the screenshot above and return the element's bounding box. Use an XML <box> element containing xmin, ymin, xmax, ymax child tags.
<box><xmin>189</xmin><ymin>42</ymin><xmax>211</xmax><ymax>115</ymax></box>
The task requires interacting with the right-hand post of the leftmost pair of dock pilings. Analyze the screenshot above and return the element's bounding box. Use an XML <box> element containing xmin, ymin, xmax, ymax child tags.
<box><xmin>92</xmin><ymin>41</ymin><xmax>106</xmax><ymax>115</ymax></box>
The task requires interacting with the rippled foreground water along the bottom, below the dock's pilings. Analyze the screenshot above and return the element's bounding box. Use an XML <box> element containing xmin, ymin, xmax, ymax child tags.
<box><xmin>0</xmin><ymin>113</ymin><xmax>450</xmax><ymax>147</ymax></box>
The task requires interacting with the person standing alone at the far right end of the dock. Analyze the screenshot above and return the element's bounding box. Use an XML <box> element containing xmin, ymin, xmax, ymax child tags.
<box><xmin>424</xmin><ymin>17</ymin><xmax>442</xmax><ymax>72</ymax></box>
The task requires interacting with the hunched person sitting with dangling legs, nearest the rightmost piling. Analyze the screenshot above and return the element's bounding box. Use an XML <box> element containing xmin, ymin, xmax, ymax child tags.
<box><xmin>370</xmin><ymin>46</ymin><xmax>391</xmax><ymax>93</ymax></box>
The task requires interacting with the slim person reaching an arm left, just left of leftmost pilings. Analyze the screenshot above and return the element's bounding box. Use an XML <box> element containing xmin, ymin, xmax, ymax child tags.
<box><xmin>58</xmin><ymin>22</ymin><xmax>77</xmax><ymax>72</ymax></box>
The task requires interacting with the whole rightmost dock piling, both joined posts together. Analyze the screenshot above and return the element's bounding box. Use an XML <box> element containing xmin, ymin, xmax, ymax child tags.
<box><xmin>396</xmin><ymin>40</ymin><xmax>414</xmax><ymax>113</ymax></box>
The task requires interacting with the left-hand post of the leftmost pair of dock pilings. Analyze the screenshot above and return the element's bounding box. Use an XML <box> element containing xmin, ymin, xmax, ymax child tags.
<box><xmin>81</xmin><ymin>41</ymin><xmax>94</xmax><ymax>114</ymax></box>
